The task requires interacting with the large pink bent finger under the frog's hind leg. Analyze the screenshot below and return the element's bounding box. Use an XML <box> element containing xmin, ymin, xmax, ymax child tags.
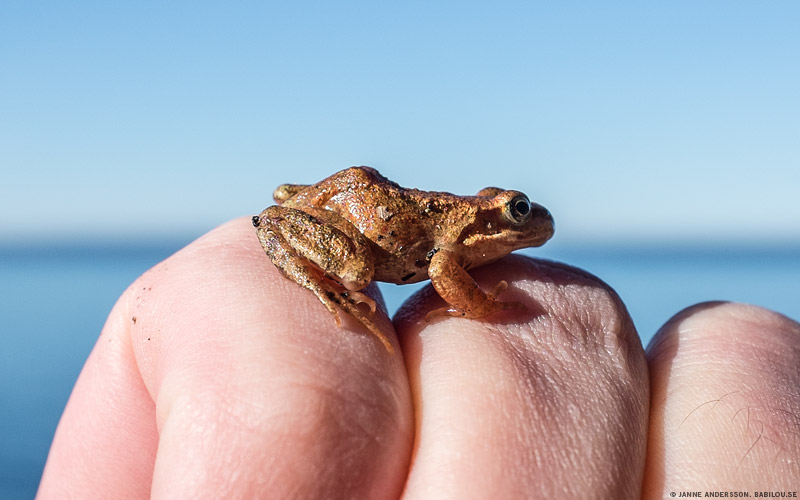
<box><xmin>38</xmin><ymin>220</ymin><xmax>412</xmax><ymax>498</ymax></box>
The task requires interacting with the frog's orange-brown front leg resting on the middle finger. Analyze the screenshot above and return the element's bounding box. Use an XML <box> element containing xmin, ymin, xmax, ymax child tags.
<box><xmin>425</xmin><ymin>250</ymin><xmax>525</xmax><ymax>320</ymax></box>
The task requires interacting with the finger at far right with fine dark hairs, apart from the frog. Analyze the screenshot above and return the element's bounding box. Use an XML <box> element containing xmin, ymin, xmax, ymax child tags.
<box><xmin>645</xmin><ymin>302</ymin><xmax>800</xmax><ymax>498</ymax></box>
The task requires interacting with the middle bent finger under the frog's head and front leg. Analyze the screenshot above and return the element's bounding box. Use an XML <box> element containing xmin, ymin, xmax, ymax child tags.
<box><xmin>395</xmin><ymin>256</ymin><xmax>648</xmax><ymax>499</ymax></box>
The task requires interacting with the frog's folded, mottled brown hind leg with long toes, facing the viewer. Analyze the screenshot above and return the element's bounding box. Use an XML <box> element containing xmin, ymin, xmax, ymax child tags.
<box><xmin>253</xmin><ymin>205</ymin><xmax>392</xmax><ymax>352</ymax></box>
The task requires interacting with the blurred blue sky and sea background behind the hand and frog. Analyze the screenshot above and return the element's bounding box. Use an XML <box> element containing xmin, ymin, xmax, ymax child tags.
<box><xmin>0</xmin><ymin>1</ymin><xmax>800</xmax><ymax>499</ymax></box>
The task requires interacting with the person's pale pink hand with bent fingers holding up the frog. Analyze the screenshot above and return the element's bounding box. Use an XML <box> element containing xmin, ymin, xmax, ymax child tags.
<box><xmin>38</xmin><ymin>219</ymin><xmax>800</xmax><ymax>499</ymax></box>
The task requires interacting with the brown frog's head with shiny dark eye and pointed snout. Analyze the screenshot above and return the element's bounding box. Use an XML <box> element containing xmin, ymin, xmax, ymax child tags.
<box><xmin>462</xmin><ymin>188</ymin><xmax>555</xmax><ymax>264</ymax></box>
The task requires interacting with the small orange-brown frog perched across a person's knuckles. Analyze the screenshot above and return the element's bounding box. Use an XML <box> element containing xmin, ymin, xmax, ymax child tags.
<box><xmin>252</xmin><ymin>166</ymin><xmax>555</xmax><ymax>353</ymax></box>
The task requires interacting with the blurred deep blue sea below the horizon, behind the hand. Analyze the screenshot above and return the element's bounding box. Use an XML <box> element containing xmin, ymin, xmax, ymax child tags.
<box><xmin>0</xmin><ymin>241</ymin><xmax>800</xmax><ymax>500</ymax></box>
